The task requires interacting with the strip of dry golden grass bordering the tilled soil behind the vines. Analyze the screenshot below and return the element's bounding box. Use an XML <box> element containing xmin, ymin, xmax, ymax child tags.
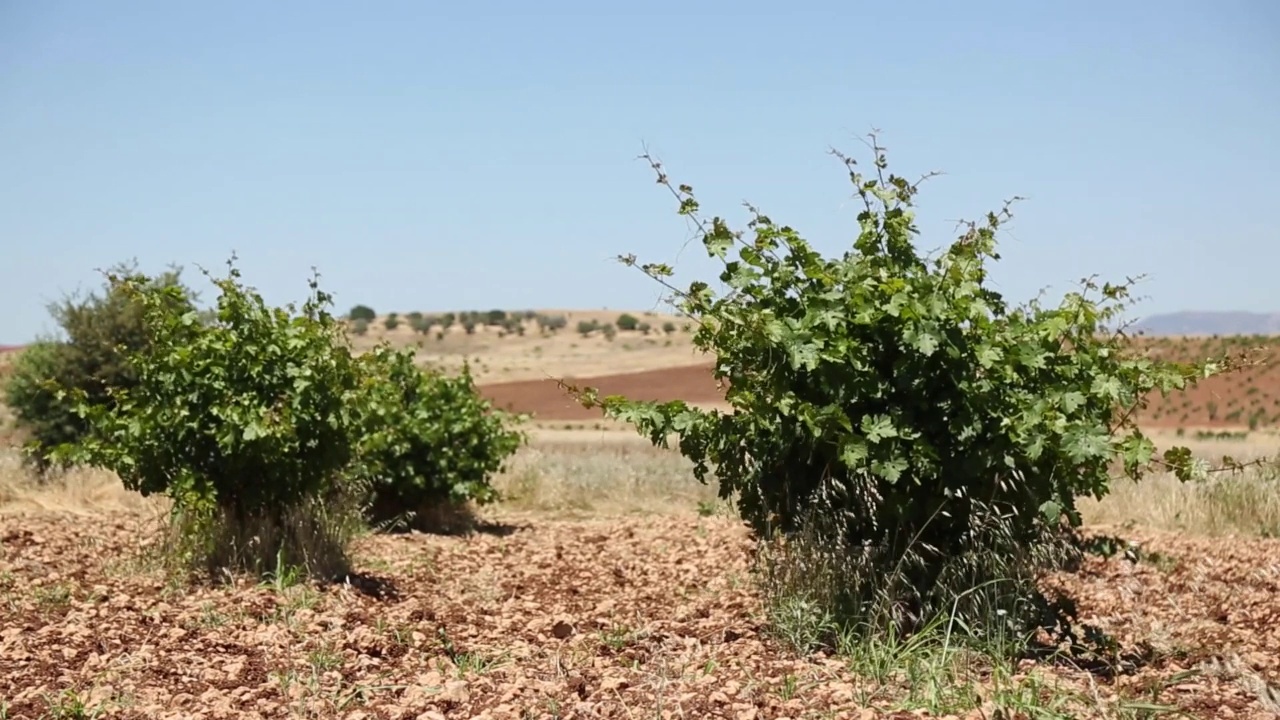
<box><xmin>0</xmin><ymin>428</ymin><xmax>1280</xmax><ymax>537</ymax></box>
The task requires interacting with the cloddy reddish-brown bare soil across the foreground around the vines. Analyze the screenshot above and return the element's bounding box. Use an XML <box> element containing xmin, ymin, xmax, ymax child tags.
<box><xmin>0</xmin><ymin>514</ymin><xmax>1280</xmax><ymax>720</ymax></box>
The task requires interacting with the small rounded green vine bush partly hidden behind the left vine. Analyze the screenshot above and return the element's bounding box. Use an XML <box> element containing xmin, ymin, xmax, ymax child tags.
<box><xmin>353</xmin><ymin>346</ymin><xmax>525</xmax><ymax>529</ymax></box>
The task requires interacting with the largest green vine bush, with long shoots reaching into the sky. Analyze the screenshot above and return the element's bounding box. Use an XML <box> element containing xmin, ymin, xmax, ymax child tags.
<box><xmin>564</xmin><ymin>137</ymin><xmax>1239</xmax><ymax>634</ymax></box>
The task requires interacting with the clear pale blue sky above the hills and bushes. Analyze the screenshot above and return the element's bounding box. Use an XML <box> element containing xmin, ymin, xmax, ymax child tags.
<box><xmin>0</xmin><ymin>0</ymin><xmax>1280</xmax><ymax>343</ymax></box>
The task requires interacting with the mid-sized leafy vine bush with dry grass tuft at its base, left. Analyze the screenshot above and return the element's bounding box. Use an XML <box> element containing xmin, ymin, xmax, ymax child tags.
<box><xmin>49</xmin><ymin>258</ymin><xmax>360</xmax><ymax>575</ymax></box>
